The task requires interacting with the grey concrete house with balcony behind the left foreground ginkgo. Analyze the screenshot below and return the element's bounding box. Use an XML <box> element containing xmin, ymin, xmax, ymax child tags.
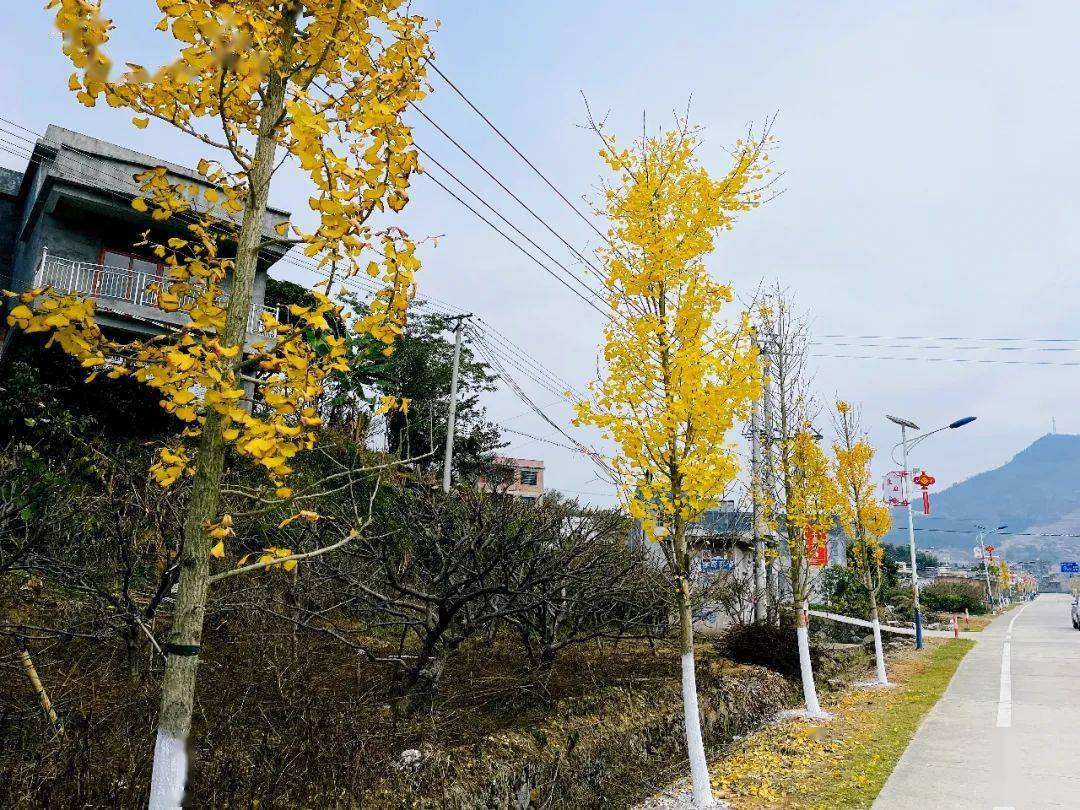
<box><xmin>0</xmin><ymin>125</ymin><xmax>288</xmax><ymax>342</ymax></box>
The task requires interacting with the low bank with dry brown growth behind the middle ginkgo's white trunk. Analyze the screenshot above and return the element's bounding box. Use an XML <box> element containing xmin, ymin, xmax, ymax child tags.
<box><xmin>364</xmin><ymin>657</ymin><xmax>792</xmax><ymax>810</ymax></box>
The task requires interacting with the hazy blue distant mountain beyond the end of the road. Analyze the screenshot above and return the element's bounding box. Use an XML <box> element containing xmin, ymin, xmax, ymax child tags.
<box><xmin>886</xmin><ymin>433</ymin><xmax>1080</xmax><ymax>562</ymax></box>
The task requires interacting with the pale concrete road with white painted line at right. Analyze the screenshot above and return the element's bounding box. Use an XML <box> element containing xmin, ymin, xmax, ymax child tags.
<box><xmin>874</xmin><ymin>594</ymin><xmax>1080</xmax><ymax>810</ymax></box>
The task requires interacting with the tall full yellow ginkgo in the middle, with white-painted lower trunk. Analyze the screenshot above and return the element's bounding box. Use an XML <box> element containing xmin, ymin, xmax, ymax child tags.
<box><xmin>576</xmin><ymin>122</ymin><xmax>770</xmax><ymax>807</ymax></box>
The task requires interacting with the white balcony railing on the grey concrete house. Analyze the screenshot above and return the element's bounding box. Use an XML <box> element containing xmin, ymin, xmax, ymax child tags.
<box><xmin>33</xmin><ymin>252</ymin><xmax>278</xmax><ymax>335</ymax></box>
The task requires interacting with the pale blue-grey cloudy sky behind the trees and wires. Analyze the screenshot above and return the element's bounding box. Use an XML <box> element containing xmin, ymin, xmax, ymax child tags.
<box><xmin>0</xmin><ymin>0</ymin><xmax>1080</xmax><ymax>502</ymax></box>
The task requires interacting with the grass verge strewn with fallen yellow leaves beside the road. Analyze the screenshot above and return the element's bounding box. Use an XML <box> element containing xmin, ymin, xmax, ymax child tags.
<box><xmin>711</xmin><ymin>639</ymin><xmax>974</xmax><ymax>810</ymax></box>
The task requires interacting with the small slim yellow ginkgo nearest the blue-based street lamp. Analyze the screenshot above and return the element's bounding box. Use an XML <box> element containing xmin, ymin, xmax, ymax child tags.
<box><xmin>833</xmin><ymin>400</ymin><xmax>892</xmax><ymax>686</ymax></box>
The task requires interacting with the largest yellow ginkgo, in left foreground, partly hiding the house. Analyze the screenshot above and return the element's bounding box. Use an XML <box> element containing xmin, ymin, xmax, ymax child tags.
<box><xmin>9</xmin><ymin>0</ymin><xmax>431</xmax><ymax>807</ymax></box>
